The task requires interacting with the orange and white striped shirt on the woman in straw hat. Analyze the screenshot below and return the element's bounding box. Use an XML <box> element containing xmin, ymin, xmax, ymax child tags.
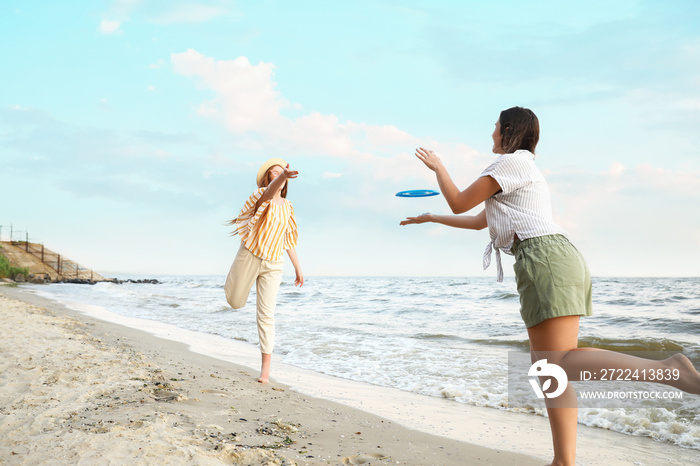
<box><xmin>234</xmin><ymin>188</ymin><xmax>299</xmax><ymax>261</ymax></box>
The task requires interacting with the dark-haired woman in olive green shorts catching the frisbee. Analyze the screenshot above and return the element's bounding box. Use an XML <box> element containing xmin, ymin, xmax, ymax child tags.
<box><xmin>401</xmin><ymin>107</ymin><xmax>700</xmax><ymax>466</ymax></box>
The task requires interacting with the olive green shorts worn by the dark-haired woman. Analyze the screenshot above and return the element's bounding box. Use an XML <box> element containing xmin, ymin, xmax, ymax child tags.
<box><xmin>513</xmin><ymin>235</ymin><xmax>593</xmax><ymax>328</ymax></box>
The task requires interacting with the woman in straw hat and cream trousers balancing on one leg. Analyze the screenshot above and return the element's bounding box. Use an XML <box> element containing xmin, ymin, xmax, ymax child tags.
<box><xmin>224</xmin><ymin>158</ymin><xmax>304</xmax><ymax>383</ymax></box>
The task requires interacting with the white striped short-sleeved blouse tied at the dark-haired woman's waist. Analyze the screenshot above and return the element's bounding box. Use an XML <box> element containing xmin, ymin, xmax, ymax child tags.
<box><xmin>481</xmin><ymin>150</ymin><xmax>566</xmax><ymax>282</ymax></box>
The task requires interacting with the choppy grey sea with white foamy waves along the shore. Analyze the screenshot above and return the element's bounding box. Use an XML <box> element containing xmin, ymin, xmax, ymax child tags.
<box><xmin>21</xmin><ymin>276</ymin><xmax>700</xmax><ymax>449</ymax></box>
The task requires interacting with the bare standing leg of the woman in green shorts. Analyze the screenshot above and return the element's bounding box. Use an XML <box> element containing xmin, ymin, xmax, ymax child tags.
<box><xmin>527</xmin><ymin>316</ymin><xmax>580</xmax><ymax>466</ymax></box>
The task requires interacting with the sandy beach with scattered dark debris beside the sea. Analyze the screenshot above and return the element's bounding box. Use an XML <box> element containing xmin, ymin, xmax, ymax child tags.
<box><xmin>0</xmin><ymin>286</ymin><xmax>700</xmax><ymax>466</ymax></box>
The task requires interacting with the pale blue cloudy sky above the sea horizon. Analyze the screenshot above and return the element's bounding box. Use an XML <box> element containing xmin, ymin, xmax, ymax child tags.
<box><xmin>0</xmin><ymin>0</ymin><xmax>700</xmax><ymax>280</ymax></box>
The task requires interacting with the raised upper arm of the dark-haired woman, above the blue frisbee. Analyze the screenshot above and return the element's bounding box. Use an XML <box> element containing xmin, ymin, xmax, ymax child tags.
<box><xmin>416</xmin><ymin>147</ymin><xmax>501</xmax><ymax>214</ymax></box>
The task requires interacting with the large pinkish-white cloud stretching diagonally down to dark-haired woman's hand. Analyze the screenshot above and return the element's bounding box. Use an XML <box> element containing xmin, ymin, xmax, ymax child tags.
<box><xmin>171</xmin><ymin>49</ymin><xmax>486</xmax><ymax>182</ymax></box>
